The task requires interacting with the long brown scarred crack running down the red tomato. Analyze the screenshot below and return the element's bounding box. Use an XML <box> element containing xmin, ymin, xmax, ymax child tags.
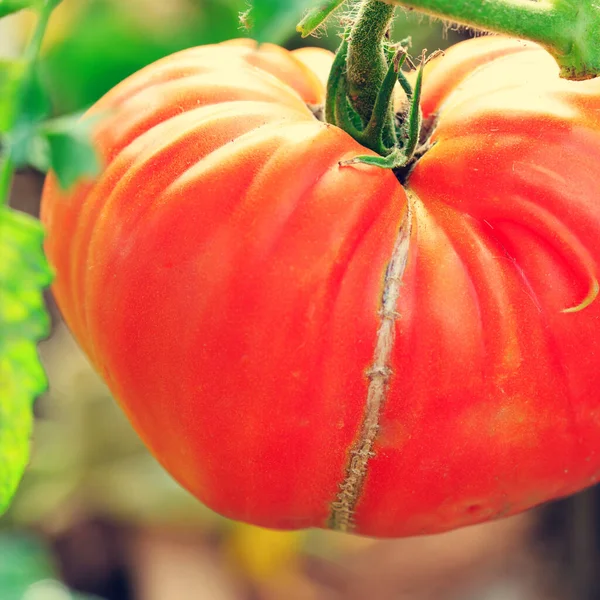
<box><xmin>328</xmin><ymin>201</ymin><xmax>412</xmax><ymax>531</ymax></box>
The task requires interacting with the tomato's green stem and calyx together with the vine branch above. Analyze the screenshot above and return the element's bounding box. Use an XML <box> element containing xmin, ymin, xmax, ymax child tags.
<box><xmin>298</xmin><ymin>0</ymin><xmax>600</xmax><ymax>166</ymax></box>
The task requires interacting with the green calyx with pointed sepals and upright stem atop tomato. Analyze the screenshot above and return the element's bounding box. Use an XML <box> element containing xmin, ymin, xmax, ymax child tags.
<box><xmin>325</xmin><ymin>0</ymin><xmax>425</xmax><ymax>169</ymax></box>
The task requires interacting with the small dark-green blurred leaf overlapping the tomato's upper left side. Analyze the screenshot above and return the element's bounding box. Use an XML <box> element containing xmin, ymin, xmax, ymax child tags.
<box><xmin>41</xmin><ymin>116</ymin><xmax>100</xmax><ymax>189</ymax></box>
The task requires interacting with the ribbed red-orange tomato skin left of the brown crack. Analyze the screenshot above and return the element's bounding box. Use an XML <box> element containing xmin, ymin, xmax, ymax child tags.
<box><xmin>43</xmin><ymin>43</ymin><xmax>406</xmax><ymax>528</ymax></box>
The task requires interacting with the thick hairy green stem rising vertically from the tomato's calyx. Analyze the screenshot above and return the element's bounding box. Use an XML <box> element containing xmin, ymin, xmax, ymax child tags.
<box><xmin>346</xmin><ymin>0</ymin><xmax>394</xmax><ymax>127</ymax></box>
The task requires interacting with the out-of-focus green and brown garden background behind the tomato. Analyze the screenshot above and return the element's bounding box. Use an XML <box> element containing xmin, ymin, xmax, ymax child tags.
<box><xmin>0</xmin><ymin>0</ymin><xmax>600</xmax><ymax>600</ymax></box>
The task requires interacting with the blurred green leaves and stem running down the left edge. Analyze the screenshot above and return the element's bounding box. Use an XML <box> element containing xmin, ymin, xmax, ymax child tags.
<box><xmin>0</xmin><ymin>0</ymin><xmax>101</xmax><ymax>514</ymax></box>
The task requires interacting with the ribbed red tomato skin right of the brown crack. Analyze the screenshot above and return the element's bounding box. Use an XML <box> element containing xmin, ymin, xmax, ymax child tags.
<box><xmin>356</xmin><ymin>38</ymin><xmax>600</xmax><ymax>535</ymax></box>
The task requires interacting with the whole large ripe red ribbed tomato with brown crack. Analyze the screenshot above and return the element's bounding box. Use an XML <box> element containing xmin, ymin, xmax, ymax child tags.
<box><xmin>43</xmin><ymin>38</ymin><xmax>600</xmax><ymax>536</ymax></box>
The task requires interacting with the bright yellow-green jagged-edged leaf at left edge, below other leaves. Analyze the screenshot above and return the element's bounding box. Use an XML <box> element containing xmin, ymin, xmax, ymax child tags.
<box><xmin>0</xmin><ymin>206</ymin><xmax>52</xmax><ymax>514</ymax></box>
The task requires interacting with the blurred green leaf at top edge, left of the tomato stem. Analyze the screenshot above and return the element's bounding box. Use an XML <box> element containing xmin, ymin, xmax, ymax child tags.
<box><xmin>248</xmin><ymin>0</ymin><xmax>315</xmax><ymax>44</ymax></box>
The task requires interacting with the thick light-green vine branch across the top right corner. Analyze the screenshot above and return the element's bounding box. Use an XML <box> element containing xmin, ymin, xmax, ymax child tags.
<box><xmin>389</xmin><ymin>0</ymin><xmax>600</xmax><ymax>79</ymax></box>
